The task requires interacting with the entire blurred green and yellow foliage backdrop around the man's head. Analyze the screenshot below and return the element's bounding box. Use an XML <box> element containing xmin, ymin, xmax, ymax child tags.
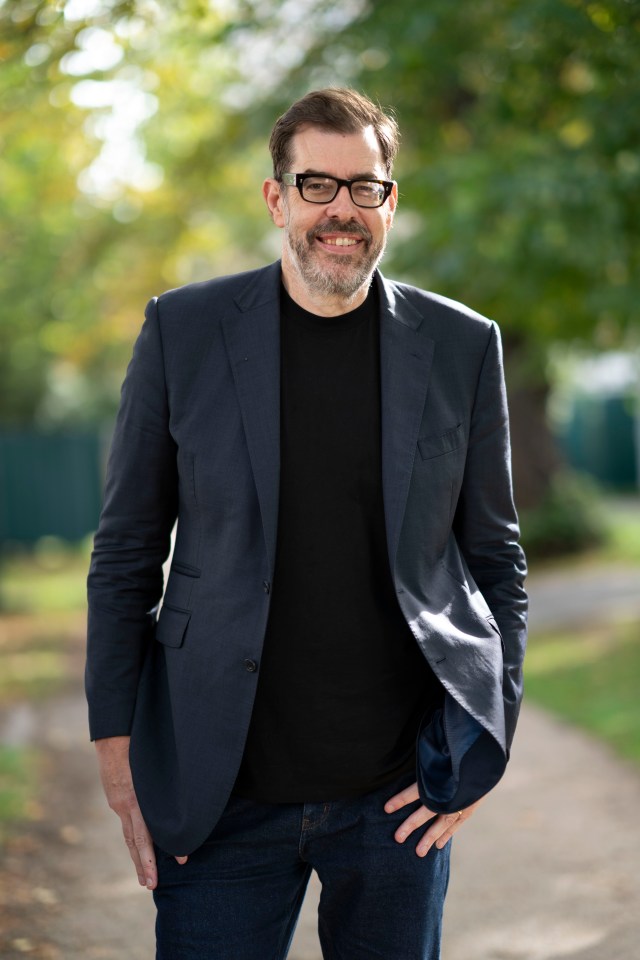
<box><xmin>0</xmin><ymin>0</ymin><xmax>640</xmax><ymax>520</ymax></box>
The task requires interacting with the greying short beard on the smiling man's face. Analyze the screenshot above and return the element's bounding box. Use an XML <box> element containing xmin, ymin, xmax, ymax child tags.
<box><xmin>287</xmin><ymin>227</ymin><xmax>385</xmax><ymax>300</ymax></box>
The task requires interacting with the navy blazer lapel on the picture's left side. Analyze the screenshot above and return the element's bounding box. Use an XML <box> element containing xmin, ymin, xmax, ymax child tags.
<box><xmin>222</xmin><ymin>263</ymin><xmax>280</xmax><ymax>576</ymax></box>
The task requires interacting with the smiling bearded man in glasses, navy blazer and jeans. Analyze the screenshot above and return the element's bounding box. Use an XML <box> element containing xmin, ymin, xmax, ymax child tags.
<box><xmin>87</xmin><ymin>89</ymin><xmax>526</xmax><ymax>960</ymax></box>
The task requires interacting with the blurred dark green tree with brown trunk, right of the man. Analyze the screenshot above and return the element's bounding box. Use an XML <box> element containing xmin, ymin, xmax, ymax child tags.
<box><xmin>236</xmin><ymin>0</ymin><xmax>640</xmax><ymax>507</ymax></box>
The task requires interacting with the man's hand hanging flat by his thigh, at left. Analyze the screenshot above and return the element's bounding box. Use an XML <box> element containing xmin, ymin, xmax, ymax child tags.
<box><xmin>96</xmin><ymin>737</ymin><xmax>187</xmax><ymax>890</ymax></box>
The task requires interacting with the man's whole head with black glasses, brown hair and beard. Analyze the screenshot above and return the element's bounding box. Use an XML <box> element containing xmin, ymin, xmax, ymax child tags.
<box><xmin>263</xmin><ymin>89</ymin><xmax>398</xmax><ymax>315</ymax></box>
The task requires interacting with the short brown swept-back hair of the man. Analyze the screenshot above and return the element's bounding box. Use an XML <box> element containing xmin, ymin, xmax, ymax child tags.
<box><xmin>269</xmin><ymin>87</ymin><xmax>400</xmax><ymax>180</ymax></box>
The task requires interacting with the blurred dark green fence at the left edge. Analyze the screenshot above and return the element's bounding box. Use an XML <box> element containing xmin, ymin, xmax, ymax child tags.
<box><xmin>0</xmin><ymin>430</ymin><xmax>104</xmax><ymax>544</ymax></box>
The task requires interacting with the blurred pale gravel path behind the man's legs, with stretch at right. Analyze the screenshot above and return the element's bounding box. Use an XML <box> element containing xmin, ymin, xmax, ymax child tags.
<box><xmin>0</xmin><ymin>568</ymin><xmax>640</xmax><ymax>960</ymax></box>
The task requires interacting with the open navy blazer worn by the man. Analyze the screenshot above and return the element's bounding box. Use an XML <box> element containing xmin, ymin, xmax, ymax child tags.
<box><xmin>86</xmin><ymin>263</ymin><xmax>526</xmax><ymax>854</ymax></box>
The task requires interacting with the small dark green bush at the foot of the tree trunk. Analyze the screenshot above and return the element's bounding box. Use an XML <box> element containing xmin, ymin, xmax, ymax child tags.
<box><xmin>520</xmin><ymin>472</ymin><xmax>607</xmax><ymax>559</ymax></box>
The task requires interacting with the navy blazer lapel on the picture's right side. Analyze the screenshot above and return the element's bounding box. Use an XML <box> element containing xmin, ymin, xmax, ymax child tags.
<box><xmin>378</xmin><ymin>274</ymin><xmax>435</xmax><ymax>576</ymax></box>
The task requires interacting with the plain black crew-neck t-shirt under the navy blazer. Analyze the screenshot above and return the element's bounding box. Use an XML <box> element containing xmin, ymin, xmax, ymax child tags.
<box><xmin>235</xmin><ymin>287</ymin><xmax>441</xmax><ymax>803</ymax></box>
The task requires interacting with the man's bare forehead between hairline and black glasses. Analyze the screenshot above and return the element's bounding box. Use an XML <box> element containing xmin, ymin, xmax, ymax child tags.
<box><xmin>291</xmin><ymin>124</ymin><xmax>384</xmax><ymax>173</ymax></box>
